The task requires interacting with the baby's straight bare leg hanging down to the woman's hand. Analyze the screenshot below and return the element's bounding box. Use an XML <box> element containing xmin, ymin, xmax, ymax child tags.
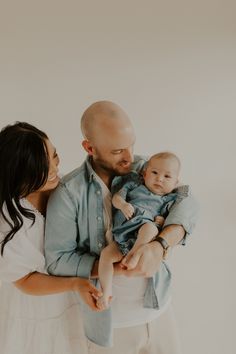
<box><xmin>97</xmin><ymin>241</ymin><xmax>123</xmax><ymax>310</ymax></box>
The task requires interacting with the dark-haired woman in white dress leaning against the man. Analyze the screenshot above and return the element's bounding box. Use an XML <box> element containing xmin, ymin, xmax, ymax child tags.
<box><xmin>0</xmin><ymin>122</ymin><xmax>100</xmax><ymax>354</ymax></box>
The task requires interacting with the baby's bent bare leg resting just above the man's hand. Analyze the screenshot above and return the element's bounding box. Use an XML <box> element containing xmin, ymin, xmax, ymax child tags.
<box><xmin>121</xmin><ymin>222</ymin><xmax>158</xmax><ymax>269</ymax></box>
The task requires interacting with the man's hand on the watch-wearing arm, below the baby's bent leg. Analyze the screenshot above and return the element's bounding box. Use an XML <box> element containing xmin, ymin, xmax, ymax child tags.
<box><xmin>121</xmin><ymin>241</ymin><xmax>163</xmax><ymax>277</ymax></box>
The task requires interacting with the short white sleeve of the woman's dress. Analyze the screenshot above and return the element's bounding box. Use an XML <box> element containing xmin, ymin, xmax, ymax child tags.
<box><xmin>0</xmin><ymin>226</ymin><xmax>45</xmax><ymax>282</ymax></box>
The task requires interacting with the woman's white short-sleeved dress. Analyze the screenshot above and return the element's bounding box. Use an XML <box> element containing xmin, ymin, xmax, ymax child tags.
<box><xmin>0</xmin><ymin>199</ymin><xmax>85</xmax><ymax>354</ymax></box>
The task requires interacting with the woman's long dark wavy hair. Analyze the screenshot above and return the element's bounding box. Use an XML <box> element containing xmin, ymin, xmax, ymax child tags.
<box><xmin>0</xmin><ymin>122</ymin><xmax>49</xmax><ymax>255</ymax></box>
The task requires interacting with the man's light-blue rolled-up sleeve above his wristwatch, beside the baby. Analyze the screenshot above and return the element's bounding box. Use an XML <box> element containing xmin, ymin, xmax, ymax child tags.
<box><xmin>164</xmin><ymin>193</ymin><xmax>200</xmax><ymax>245</ymax></box>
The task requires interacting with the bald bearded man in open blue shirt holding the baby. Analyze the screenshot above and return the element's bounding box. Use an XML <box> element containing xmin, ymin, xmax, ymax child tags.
<box><xmin>45</xmin><ymin>101</ymin><xmax>197</xmax><ymax>354</ymax></box>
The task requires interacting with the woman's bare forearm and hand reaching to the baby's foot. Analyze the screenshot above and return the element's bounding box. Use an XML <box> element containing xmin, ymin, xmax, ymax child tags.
<box><xmin>13</xmin><ymin>272</ymin><xmax>101</xmax><ymax>311</ymax></box>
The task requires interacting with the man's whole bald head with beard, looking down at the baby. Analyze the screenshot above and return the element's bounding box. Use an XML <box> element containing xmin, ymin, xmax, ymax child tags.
<box><xmin>81</xmin><ymin>101</ymin><xmax>135</xmax><ymax>180</ymax></box>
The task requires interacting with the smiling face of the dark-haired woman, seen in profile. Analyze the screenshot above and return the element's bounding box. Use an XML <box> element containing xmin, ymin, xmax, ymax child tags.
<box><xmin>40</xmin><ymin>140</ymin><xmax>60</xmax><ymax>192</ymax></box>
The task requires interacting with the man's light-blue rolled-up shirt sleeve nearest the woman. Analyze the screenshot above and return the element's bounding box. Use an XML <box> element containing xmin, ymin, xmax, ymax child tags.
<box><xmin>45</xmin><ymin>185</ymin><xmax>96</xmax><ymax>278</ymax></box>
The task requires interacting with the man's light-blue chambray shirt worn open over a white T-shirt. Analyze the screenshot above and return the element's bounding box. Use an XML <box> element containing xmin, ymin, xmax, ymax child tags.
<box><xmin>45</xmin><ymin>156</ymin><xmax>198</xmax><ymax>346</ymax></box>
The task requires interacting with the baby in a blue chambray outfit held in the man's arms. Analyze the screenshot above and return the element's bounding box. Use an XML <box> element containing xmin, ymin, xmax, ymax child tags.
<box><xmin>97</xmin><ymin>152</ymin><xmax>187</xmax><ymax>310</ymax></box>
